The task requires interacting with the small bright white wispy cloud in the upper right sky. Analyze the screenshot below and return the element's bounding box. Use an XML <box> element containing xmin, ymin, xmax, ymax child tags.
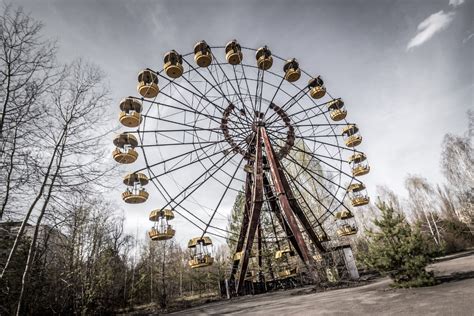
<box><xmin>407</xmin><ymin>10</ymin><xmax>461</xmax><ymax>50</ymax></box>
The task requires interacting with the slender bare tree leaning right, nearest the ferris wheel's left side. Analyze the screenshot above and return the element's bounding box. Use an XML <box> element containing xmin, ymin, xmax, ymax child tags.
<box><xmin>12</xmin><ymin>60</ymin><xmax>108</xmax><ymax>315</ymax></box>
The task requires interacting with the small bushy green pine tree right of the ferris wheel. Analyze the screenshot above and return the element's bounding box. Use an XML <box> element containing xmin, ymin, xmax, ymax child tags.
<box><xmin>363</xmin><ymin>201</ymin><xmax>435</xmax><ymax>287</ymax></box>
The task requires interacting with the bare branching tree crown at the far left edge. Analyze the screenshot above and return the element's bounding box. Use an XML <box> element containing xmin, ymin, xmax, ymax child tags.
<box><xmin>0</xmin><ymin>5</ymin><xmax>57</xmax><ymax>219</ymax></box>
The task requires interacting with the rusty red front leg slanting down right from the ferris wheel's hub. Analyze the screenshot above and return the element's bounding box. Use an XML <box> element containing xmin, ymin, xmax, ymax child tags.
<box><xmin>260</xmin><ymin>127</ymin><xmax>314</xmax><ymax>271</ymax></box>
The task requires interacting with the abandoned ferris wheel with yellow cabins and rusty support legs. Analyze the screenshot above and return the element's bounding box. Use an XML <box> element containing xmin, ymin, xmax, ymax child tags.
<box><xmin>113</xmin><ymin>40</ymin><xmax>370</xmax><ymax>293</ymax></box>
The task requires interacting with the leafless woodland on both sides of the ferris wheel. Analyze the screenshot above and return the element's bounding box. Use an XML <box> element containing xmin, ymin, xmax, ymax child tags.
<box><xmin>0</xmin><ymin>5</ymin><xmax>474</xmax><ymax>315</ymax></box>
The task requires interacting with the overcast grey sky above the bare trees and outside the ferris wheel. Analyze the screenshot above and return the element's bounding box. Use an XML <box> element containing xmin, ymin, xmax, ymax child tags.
<box><xmin>10</xmin><ymin>0</ymin><xmax>474</xmax><ymax>241</ymax></box>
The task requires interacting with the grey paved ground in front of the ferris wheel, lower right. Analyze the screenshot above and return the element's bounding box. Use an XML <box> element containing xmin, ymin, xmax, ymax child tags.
<box><xmin>174</xmin><ymin>255</ymin><xmax>474</xmax><ymax>316</ymax></box>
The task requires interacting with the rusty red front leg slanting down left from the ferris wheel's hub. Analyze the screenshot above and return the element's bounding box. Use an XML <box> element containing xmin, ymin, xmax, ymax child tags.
<box><xmin>237</xmin><ymin>129</ymin><xmax>263</xmax><ymax>294</ymax></box>
